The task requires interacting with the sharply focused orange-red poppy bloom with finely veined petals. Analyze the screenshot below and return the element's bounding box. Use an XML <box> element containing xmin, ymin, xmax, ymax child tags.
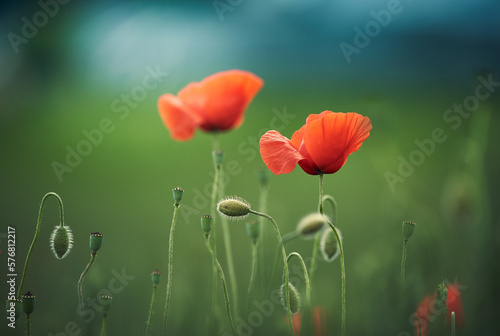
<box><xmin>259</xmin><ymin>111</ymin><xmax>372</xmax><ymax>175</ymax></box>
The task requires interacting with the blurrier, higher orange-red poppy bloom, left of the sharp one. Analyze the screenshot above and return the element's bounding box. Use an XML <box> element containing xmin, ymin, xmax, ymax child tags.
<box><xmin>158</xmin><ymin>70</ymin><xmax>264</xmax><ymax>141</ymax></box>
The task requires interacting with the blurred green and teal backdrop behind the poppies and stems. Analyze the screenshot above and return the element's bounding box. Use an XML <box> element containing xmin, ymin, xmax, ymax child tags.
<box><xmin>0</xmin><ymin>0</ymin><xmax>500</xmax><ymax>336</ymax></box>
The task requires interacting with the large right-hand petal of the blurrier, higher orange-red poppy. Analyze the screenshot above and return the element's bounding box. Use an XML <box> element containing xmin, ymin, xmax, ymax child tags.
<box><xmin>178</xmin><ymin>70</ymin><xmax>264</xmax><ymax>131</ymax></box>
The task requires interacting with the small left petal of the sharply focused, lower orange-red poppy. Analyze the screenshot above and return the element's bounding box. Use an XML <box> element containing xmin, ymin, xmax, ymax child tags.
<box><xmin>259</xmin><ymin>131</ymin><xmax>304</xmax><ymax>175</ymax></box>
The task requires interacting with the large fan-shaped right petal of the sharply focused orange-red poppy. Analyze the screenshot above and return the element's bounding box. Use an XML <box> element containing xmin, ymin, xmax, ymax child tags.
<box><xmin>304</xmin><ymin>111</ymin><xmax>372</xmax><ymax>174</ymax></box>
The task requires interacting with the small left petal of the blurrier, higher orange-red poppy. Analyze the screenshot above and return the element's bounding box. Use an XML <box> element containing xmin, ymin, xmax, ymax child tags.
<box><xmin>158</xmin><ymin>93</ymin><xmax>200</xmax><ymax>141</ymax></box>
